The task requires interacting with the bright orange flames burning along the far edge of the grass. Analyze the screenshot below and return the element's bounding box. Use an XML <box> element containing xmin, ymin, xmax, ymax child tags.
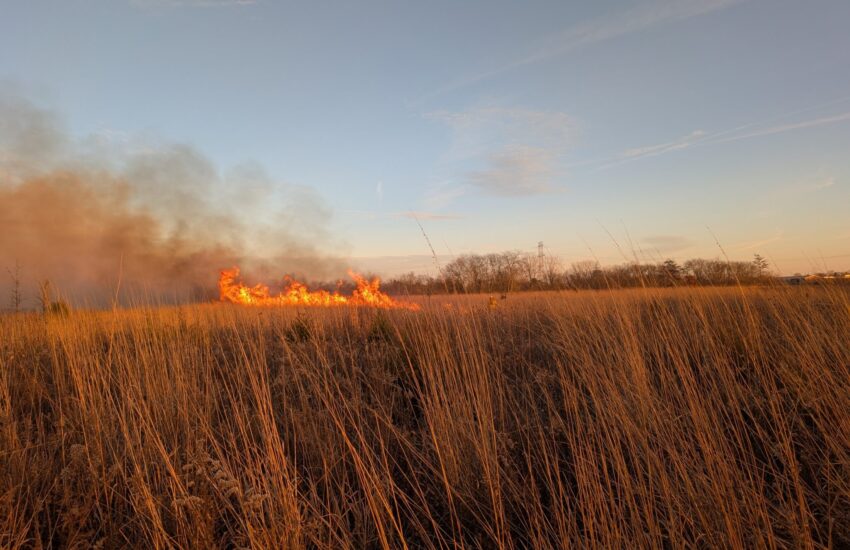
<box><xmin>218</xmin><ymin>267</ymin><xmax>419</xmax><ymax>311</ymax></box>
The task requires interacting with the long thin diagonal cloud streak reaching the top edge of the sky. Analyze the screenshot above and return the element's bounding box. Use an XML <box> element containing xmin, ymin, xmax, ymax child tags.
<box><xmin>417</xmin><ymin>0</ymin><xmax>744</xmax><ymax>101</ymax></box>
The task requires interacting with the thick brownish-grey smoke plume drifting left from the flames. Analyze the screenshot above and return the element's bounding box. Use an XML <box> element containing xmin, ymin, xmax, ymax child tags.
<box><xmin>0</xmin><ymin>89</ymin><xmax>343</xmax><ymax>308</ymax></box>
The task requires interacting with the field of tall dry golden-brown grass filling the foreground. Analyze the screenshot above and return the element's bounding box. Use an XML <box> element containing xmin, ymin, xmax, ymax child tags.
<box><xmin>0</xmin><ymin>288</ymin><xmax>850</xmax><ymax>548</ymax></box>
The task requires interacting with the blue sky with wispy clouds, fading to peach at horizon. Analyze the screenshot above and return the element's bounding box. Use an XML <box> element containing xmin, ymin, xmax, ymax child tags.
<box><xmin>0</xmin><ymin>0</ymin><xmax>850</xmax><ymax>274</ymax></box>
